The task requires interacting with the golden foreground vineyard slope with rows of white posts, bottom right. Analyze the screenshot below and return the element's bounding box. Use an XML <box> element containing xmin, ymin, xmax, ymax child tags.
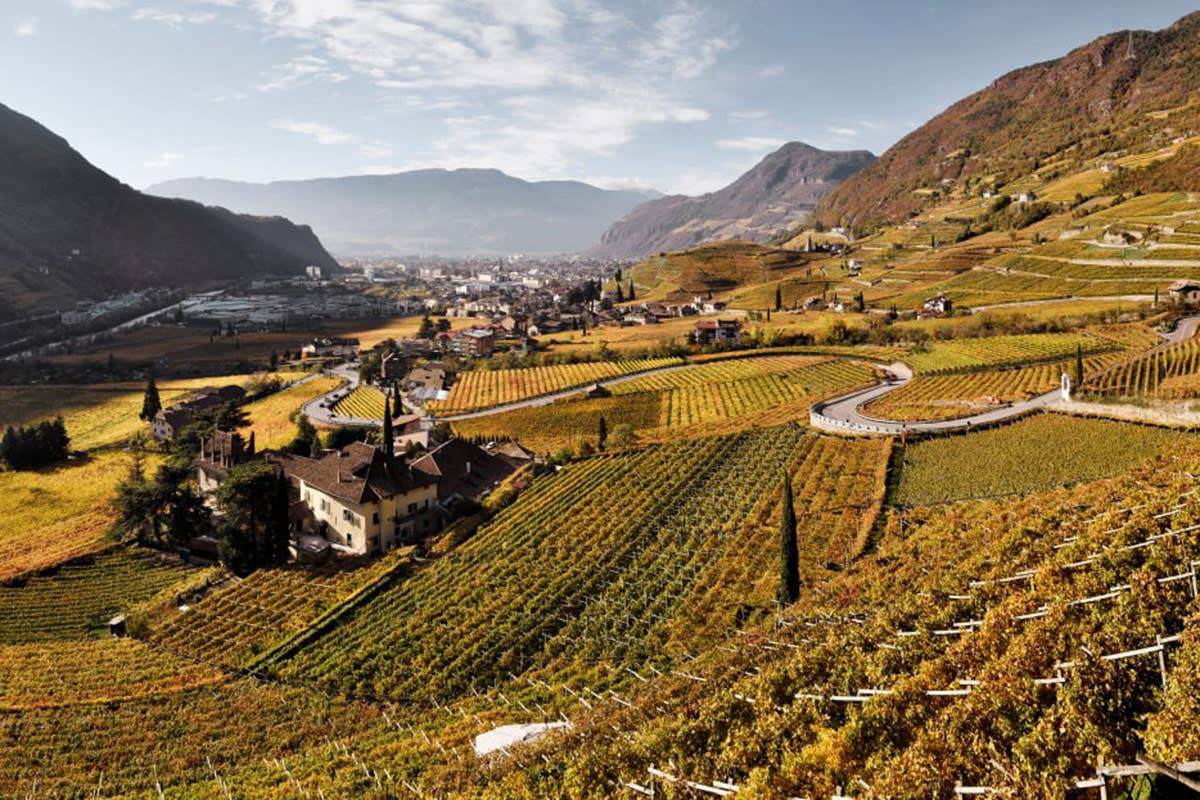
<box><xmin>475</xmin><ymin>451</ymin><xmax>1200</xmax><ymax>798</ymax></box>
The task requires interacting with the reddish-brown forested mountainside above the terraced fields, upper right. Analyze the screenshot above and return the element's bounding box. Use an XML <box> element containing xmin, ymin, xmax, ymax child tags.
<box><xmin>816</xmin><ymin>12</ymin><xmax>1200</xmax><ymax>227</ymax></box>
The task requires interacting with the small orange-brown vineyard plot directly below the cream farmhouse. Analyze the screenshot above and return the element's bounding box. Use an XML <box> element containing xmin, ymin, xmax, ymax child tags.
<box><xmin>152</xmin><ymin>551</ymin><xmax>398</xmax><ymax>667</ymax></box>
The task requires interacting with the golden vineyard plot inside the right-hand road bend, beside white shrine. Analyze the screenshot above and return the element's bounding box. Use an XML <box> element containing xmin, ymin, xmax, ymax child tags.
<box><xmin>863</xmin><ymin>353</ymin><xmax>1124</xmax><ymax>421</ymax></box>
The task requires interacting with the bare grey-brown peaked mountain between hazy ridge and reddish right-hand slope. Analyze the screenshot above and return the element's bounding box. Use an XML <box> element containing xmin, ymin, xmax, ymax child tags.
<box><xmin>590</xmin><ymin>142</ymin><xmax>875</xmax><ymax>258</ymax></box>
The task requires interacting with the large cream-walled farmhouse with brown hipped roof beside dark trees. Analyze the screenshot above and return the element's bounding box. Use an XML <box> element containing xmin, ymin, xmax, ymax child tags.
<box><xmin>269</xmin><ymin>441</ymin><xmax>440</xmax><ymax>554</ymax></box>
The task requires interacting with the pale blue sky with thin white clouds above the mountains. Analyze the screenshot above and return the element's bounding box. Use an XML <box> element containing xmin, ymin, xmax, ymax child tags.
<box><xmin>0</xmin><ymin>0</ymin><xmax>1200</xmax><ymax>194</ymax></box>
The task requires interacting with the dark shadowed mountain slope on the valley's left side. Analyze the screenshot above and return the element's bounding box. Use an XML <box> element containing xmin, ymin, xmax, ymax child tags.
<box><xmin>0</xmin><ymin>104</ymin><xmax>337</xmax><ymax>319</ymax></box>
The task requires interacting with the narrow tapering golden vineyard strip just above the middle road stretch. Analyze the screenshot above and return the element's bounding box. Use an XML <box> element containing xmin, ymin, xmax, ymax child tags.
<box><xmin>426</xmin><ymin>359</ymin><xmax>683</xmax><ymax>416</ymax></box>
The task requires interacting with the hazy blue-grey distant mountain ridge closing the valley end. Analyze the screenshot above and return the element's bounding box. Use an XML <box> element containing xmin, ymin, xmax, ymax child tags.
<box><xmin>148</xmin><ymin>169</ymin><xmax>646</xmax><ymax>255</ymax></box>
